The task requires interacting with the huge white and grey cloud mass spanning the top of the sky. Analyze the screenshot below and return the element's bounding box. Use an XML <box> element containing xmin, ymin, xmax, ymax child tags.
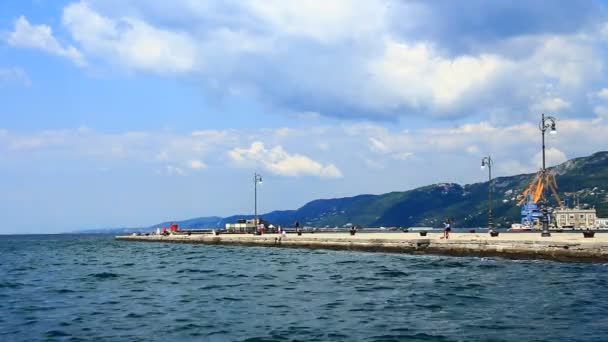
<box><xmin>7</xmin><ymin>0</ymin><xmax>606</xmax><ymax>123</ymax></box>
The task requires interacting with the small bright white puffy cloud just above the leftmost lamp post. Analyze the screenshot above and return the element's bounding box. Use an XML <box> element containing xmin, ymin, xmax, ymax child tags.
<box><xmin>228</xmin><ymin>141</ymin><xmax>342</xmax><ymax>178</ymax></box>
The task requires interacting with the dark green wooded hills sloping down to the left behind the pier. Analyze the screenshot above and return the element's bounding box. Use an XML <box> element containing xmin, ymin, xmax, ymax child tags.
<box><xmin>76</xmin><ymin>151</ymin><xmax>608</xmax><ymax>234</ymax></box>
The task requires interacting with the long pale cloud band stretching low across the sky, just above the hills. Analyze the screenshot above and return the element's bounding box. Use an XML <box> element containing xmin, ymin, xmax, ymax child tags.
<box><xmin>0</xmin><ymin>111</ymin><xmax>608</xmax><ymax>190</ymax></box>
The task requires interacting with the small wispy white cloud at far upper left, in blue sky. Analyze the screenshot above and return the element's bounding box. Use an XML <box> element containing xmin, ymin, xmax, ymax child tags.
<box><xmin>7</xmin><ymin>16</ymin><xmax>85</xmax><ymax>66</ymax></box>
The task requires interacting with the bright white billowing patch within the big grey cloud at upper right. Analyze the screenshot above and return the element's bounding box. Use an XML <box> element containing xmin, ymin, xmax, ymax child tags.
<box><xmin>369</xmin><ymin>39</ymin><xmax>512</xmax><ymax>111</ymax></box>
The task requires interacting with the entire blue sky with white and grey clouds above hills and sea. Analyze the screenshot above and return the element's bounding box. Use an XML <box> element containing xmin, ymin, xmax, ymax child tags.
<box><xmin>0</xmin><ymin>0</ymin><xmax>608</xmax><ymax>234</ymax></box>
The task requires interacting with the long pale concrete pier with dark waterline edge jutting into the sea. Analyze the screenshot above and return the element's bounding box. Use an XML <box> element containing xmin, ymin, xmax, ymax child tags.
<box><xmin>116</xmin><ymin>232</ymin><xmax>608</xmax><ymax>262</ymax></box>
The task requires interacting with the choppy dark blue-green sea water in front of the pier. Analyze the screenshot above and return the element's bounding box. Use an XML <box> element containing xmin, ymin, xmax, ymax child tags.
<box><xmin>0</xmin><ymin>235</ymin><xmax>608</xmax><ymax>341</ymax></box>
